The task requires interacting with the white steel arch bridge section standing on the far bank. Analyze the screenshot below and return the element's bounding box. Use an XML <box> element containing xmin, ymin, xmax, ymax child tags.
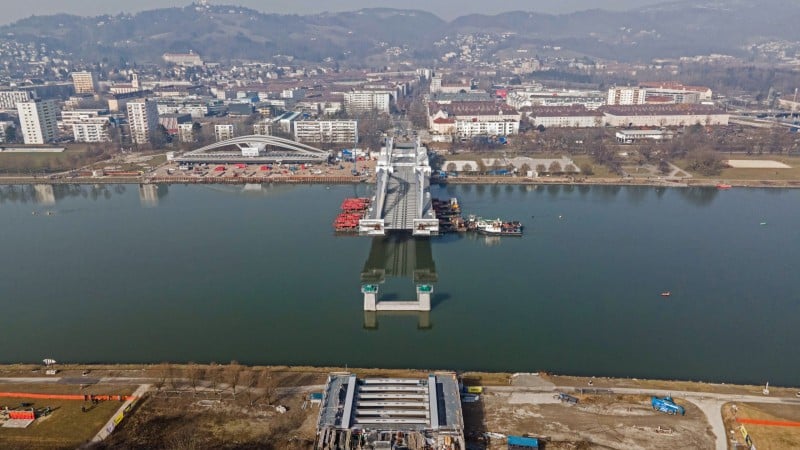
<box><xmin>175</xmin><ymin>135</ymin><xmax>330</xmax><ymax>164</ymax></box>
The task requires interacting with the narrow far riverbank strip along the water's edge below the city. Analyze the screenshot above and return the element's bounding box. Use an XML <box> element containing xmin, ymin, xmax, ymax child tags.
<box><xmin>0</xmin><ymin>171</ymin><xmax>800</xmax><ymax>189</ymax></box>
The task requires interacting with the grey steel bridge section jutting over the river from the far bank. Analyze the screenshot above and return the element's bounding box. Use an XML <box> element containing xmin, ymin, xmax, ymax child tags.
<box><xmin>358</xmin><ymin>138</ymin><xmax>439</xmax><ymax>236</ymax></box>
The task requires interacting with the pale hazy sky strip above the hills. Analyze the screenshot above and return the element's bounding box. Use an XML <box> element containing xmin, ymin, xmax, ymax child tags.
<box><xmin>0</xmin><ymin>0</ymin><xmax>669</xmax><ymax>24</ymax></box>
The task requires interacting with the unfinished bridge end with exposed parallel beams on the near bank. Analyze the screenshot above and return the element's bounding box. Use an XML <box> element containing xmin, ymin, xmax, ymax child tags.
<box><xmin>314</xmin><ymin>372</ymin><xmax>466</xmax><ymax>450</ymax></box>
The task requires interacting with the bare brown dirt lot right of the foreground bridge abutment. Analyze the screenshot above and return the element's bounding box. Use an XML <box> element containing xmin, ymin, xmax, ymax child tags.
<box><xmin>464</xmin><ymin>389</ymin><xmax>714</xmax><ymax>450</ymax></box>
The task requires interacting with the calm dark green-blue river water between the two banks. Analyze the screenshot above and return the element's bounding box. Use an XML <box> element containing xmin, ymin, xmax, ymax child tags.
<box><xmin>0</xmin><ymin>185</ymin><xmax>800</xmax><ymax>385</ymax></box>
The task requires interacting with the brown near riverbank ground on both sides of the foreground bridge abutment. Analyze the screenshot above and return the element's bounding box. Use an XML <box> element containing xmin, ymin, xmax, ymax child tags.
<box><xmin>0</xmin><ymin>361</ymin><xmax>800</xmax><ymax>450</ymax></box>
